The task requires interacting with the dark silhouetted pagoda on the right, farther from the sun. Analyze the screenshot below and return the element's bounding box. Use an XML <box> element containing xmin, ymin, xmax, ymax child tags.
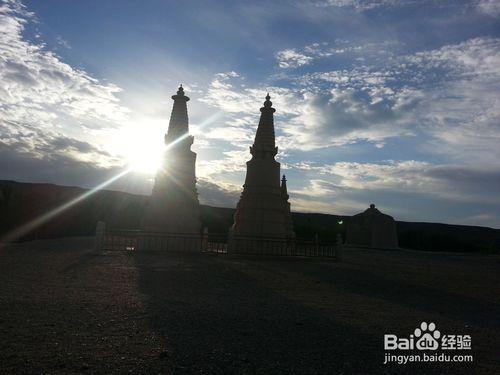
<box><xmin>231</xmin><ymin>94</ymin><xmax>295</xmax><ymax>243</ymax></box>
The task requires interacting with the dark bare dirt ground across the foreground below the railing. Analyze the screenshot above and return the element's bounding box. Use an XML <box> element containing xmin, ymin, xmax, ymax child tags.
<box><xmin>0</xmin><ymin>238</ymin><xmax>500</xmax><ymax>374</ymax></box>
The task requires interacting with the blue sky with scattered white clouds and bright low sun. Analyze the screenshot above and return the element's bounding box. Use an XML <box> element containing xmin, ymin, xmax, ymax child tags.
<box><xmin>0</xmin><ymin>0</ymin><xmax>500</xmax><ymax>228</ymax></box>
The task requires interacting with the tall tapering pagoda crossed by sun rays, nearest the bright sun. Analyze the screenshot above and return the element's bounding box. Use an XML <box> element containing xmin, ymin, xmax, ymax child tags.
<box><xmin>143</xmin><ymin>85</ymin><xmax>201</xmax><ymax>234</ymax></box>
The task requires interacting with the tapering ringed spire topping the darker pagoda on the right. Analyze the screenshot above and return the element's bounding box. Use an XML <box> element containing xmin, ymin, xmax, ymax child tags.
<box><xmin>250</xmin><ymin>93</ymin><xmax>278</xmax><ymax>158</ymax></box>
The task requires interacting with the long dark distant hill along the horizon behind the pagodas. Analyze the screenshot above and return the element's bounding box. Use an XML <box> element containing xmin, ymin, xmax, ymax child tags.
<box><xmin>0</xmin><ymin>180</ymin><xmax>500</xmax><ymax>252</ymax></box>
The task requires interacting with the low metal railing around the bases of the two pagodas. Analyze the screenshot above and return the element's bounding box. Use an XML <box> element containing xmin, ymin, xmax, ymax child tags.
<box><xmin>96</xmin><ymin>229</ymin><xmax>340</xmax><ymax>257</ymax></box>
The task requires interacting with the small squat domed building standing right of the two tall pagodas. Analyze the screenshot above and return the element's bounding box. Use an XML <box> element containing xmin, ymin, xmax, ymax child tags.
<box><xmin>346</xmin><ymin>204</ymin><xmax>398</xmax><ymax>249</ymax></box>
